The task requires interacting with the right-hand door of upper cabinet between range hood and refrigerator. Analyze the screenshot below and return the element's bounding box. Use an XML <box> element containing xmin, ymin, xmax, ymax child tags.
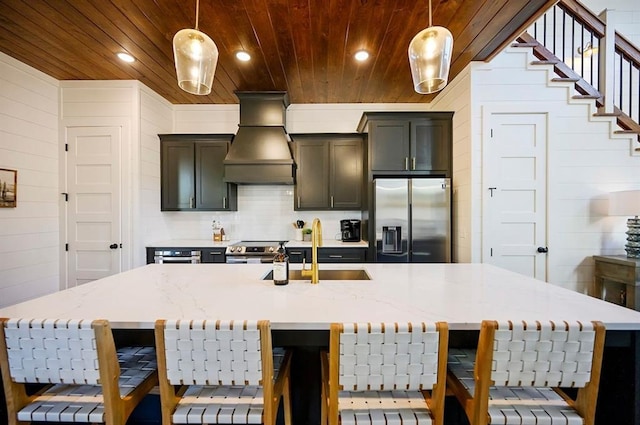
<box><xmin>330</xmin><ymin>139</ymin><xmax>364</xmax><ymax>210</ymax></box>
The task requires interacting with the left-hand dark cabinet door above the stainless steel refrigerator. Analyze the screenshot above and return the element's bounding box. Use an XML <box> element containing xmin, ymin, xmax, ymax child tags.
<box><xmin>369</xmin><ymin>120</ymin><xmax>410</xmax><ymax>171</ymax></box>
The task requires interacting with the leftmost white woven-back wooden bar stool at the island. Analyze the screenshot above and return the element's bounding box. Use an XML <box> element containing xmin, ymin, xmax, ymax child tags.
<box><xmin>0</xmin><ymin>319</ymin><xmax>158</xmax><ymax>425</ymax></box>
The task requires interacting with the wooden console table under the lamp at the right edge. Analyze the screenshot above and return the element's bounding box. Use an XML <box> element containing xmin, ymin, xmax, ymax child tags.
<box><xmin>591</xmin><ymin>255</ymin><xmax>640</xmax><ymax>311</ymax></box>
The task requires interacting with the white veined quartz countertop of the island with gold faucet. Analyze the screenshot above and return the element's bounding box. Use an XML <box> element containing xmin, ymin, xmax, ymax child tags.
<box><xmin>0</xmin><ymin>263</ymin><xmax>640</xmax><ymax>330</ymax></box>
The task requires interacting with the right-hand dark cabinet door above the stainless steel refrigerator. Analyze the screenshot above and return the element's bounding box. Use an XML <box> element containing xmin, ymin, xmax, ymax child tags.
<box><xmin>411</xmin><ymin>119</ymin><xmax>451</xmax><ymax>172</ymax></box>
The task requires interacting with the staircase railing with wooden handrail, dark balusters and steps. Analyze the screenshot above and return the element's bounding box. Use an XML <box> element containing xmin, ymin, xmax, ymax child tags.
<box><xmin>513</xmin><ymin>0</ymin><xmax>640</xmax><ymax>155</ymax></box>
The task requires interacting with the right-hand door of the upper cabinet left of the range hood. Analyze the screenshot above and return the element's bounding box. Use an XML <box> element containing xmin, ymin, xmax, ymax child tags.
<box><xmin>195</xmin><ymin>142</ymin><xmax>229</xmax><ymax>210</ymax></box>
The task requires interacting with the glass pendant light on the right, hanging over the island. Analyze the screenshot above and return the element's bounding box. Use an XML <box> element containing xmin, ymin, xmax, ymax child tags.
<box><xmin>408</xmin><ymin>0</ymin><xmax>453</xmax><ymax>94</ymax></box>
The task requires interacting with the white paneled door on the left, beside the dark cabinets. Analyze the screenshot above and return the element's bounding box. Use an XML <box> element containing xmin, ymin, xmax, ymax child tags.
<box><xmin>66</xmin><ymin>126</ymin><xmax>122</xmax><ymax>287</ymax></box>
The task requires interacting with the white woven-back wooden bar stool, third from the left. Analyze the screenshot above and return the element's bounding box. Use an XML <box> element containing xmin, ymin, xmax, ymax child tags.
<box><xmin>321</xmin><ymin>322</ymin><xmax>449</xmax><ymax>425</ymax></box>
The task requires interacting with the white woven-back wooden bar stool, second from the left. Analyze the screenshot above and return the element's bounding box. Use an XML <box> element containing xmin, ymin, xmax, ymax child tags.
<box><xmin>155</xmin><ymin>320</ymin><xmax>291</xmax><ymax>425</ymax></box>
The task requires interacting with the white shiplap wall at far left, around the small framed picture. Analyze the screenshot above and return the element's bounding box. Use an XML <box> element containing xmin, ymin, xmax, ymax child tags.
<box><xmin>0</xmin><ymin>53</ymin><xmax>60</xmax><ymax>307</ymax></box>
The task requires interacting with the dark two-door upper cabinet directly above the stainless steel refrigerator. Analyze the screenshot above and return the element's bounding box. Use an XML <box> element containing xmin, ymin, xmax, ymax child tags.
<box><xmin>358</xmin><ymin>112</ymin><xmax>453</xmax><ymax>176</ymax></box>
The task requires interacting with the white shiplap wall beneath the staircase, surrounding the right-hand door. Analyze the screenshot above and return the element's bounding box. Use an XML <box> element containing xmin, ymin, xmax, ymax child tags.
<box><xmin>471</xmin><ymin>48</ymin><xmax>640</xmax><ymax>292</ymax></box>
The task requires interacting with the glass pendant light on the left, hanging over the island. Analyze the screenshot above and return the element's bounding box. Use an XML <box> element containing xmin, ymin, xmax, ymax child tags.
<box><xmin>173</xmin><ymin>0</ymin><xmax>218</xmax><ymax>95</ymax></box>
